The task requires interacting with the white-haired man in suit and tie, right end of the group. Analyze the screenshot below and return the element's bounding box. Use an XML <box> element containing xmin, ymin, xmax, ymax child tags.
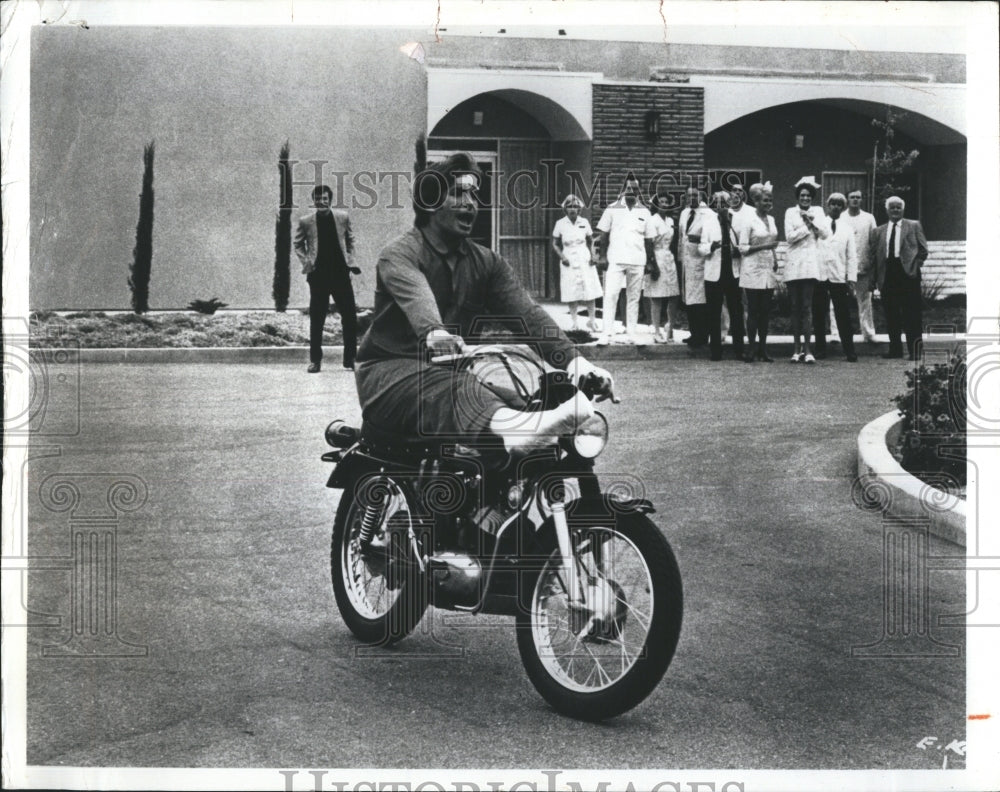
<box><xmin>871</xmin><ymin>195</ymin><xmax>927</xmax><ymax>360</ymax></box>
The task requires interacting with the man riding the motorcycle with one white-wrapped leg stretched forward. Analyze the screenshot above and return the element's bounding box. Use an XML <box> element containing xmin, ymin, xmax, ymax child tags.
<box><xmin>355</xmin><ymin>153</ymin><xmax>614</xmax><ymax>451</ymax></box>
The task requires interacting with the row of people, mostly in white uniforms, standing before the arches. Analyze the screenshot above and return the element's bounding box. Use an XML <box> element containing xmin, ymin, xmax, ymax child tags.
<box><xmin>553</xmin><ymin>176</ymin><xmax>927</xmax><ymax>364</ymax></box>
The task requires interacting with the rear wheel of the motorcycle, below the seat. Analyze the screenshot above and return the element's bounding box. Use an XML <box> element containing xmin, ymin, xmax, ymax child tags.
<box><xmin>330</xmin><ymin>477</ymin><xmax>428</xmax><ymax>646</ymax></box>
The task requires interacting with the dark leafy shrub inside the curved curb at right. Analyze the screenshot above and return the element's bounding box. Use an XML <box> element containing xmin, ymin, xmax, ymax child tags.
<box><xmin>892</xmin><ymin>350</ymin><xmax>966</xmax><ymax>487</ymax></box>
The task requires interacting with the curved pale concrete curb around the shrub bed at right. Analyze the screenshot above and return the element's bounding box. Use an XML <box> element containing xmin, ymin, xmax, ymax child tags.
<box><xmin>854</xmin><ymin>410</ymin><xmax>966</xmax><ymax>547</ymax></box>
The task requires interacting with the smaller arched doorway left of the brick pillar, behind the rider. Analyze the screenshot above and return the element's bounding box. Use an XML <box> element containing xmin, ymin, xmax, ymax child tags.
<box><xmin>428</xmin><ymin>89</ymin><xmax>590</xmax><ymax>299</ymax></box>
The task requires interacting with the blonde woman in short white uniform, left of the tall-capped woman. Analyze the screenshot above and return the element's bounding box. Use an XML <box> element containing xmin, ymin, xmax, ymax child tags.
<box><xmin>740</xmin><ymin>182</ymin><xmax>778</xmax><ymax>363</ymax></box>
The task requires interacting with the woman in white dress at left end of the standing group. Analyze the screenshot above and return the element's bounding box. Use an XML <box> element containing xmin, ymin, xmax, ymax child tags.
<box><xmin>552</xmin><ymin>195</ymin><xmax>602</xmax><ymax>332</ymax></box>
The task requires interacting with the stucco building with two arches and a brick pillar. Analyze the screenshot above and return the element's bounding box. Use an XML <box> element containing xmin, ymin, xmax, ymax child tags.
<box><xmin>30</xmin><ymin>28</ymin><xmax>968</xmax><ymax>309</ymax></box>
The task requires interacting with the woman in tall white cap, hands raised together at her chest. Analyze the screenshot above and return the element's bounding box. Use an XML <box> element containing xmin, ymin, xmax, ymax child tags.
<box><xmin>784</xmin><ymin>176</ymin><xmax>830</xmax><ymax>363</ymax></box>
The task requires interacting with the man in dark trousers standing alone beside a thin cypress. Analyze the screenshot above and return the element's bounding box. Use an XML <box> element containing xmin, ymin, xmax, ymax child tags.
<box><xmin>295</xmin><ymin>184</ymin><xmax>361</xmax><ymax>374</ymax></box>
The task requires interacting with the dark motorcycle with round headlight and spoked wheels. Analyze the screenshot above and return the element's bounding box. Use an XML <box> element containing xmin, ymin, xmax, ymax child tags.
<box><xmin>323</xmin><ymin>346</ymin><xmax>683</xmax><ymax>721</ymax></box>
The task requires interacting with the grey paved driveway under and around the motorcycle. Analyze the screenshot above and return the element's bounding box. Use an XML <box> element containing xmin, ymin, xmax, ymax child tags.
<box><xmin>19</xmin><ymin>357</ymin><xmax>966</xmax><ymax>781</ymax></box>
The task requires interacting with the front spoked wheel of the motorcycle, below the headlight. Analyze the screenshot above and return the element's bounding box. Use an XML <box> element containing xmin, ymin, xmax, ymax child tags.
<box><xmin>517</xmin><ymin>513</ymin><xmax>683</xmax><ymax>721</ymax></box>
